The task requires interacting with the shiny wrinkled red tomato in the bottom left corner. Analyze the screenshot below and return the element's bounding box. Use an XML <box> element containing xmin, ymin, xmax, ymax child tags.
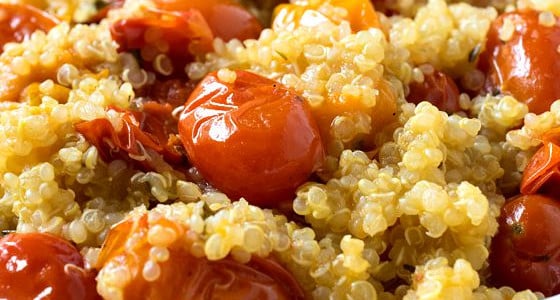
<box><xmin>0</xmin><ymin>233</ymin><xmax>100</xmax><ymax>300</ymax></box>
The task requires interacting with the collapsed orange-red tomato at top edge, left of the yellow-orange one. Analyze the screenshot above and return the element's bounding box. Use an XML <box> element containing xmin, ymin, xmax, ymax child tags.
<box><xmin>111</xmin><ymin>0</ymin><xmax>262</xmax><ymax>75</ymax></box>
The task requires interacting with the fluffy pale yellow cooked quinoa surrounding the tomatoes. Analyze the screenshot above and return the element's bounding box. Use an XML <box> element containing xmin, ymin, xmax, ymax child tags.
<box><xmin>0</xmin><ymin>0</ymin><xmax>560</xmax><ymax>300</ymax></box>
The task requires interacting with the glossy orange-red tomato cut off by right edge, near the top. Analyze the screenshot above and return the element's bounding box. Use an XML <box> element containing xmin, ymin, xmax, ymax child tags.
<box><xmin>480</xmin><ymin>10</ymin><xmax>560</xmax><ymax>113</ymax></box>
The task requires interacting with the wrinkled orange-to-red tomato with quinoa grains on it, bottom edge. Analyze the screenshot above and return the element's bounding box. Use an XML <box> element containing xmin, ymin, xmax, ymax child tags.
<box><xmin>97</xmin><ymin>213</ymin><xmax>303</xmax><ymax>300</ymax></box>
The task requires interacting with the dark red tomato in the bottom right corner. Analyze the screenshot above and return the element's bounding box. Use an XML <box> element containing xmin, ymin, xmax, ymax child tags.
<box><xmin>489</xmin><ymin>194</ymin><xmax>560</xmax><ymax>296</ymax></box>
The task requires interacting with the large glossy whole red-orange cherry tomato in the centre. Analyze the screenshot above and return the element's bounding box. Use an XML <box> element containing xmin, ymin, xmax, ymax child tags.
<box><xmin>179</xmin><ymin>71</ymin><xmax>324</xmax><ymax>207</ymax></box>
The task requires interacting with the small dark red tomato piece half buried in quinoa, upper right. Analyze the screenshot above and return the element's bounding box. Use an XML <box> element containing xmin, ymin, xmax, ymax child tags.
<box><xmin>406</xmin><ymin>66</ymin><xmax>461</xmax><ymax>113</ymax></box>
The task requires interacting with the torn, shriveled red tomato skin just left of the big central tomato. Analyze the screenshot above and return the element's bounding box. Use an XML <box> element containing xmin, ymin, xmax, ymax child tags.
<box><xmin>74</xmin><ymin>101</ymin><xmax>184</xmax><ymax>171</ymax></box>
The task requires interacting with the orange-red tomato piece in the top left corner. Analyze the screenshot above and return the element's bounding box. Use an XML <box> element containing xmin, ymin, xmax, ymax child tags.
<box><xmin>0</xmin><ymin>3</ymin><xmax>59</xmax><ymax>53</ymax></box>
